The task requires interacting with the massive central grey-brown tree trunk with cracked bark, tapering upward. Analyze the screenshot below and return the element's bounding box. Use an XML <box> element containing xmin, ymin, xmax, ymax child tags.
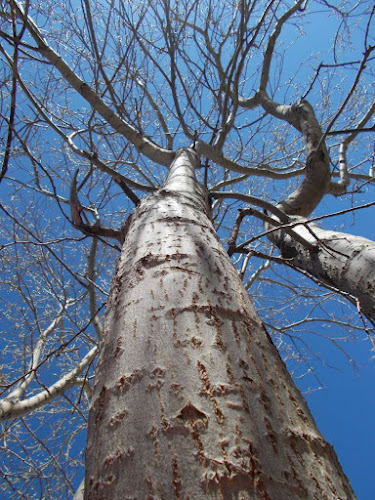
<box><xmin>85</xmin><ymin>150</ymin><xmax>355</xmax><ymax>500</ymax></box>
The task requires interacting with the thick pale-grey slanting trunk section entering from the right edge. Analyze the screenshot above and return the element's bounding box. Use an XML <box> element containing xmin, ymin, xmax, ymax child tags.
<box><xmin>270</xmin><ymin>219</ymin><xmax>375</xmax><ymax>320</ymax></box>
